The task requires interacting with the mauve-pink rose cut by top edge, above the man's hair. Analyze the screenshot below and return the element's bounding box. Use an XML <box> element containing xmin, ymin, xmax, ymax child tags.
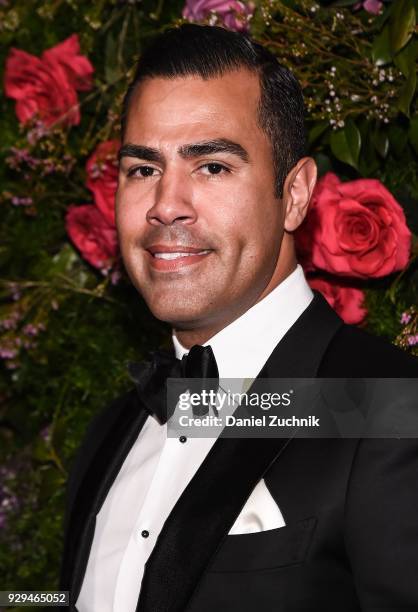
<box><xmin>183</xmin><ymin>0</ymin><xmax>255</xmax><ymax>31</ymax></box>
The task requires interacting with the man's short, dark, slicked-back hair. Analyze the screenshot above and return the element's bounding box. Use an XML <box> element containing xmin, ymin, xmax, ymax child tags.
<box><xmin>122</xmin><ymin>24</ymin><xmax>306</xmax><ymax>197</ymax></box>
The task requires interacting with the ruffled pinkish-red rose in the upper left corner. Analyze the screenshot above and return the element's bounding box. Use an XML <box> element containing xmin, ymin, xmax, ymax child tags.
<box><xmin>4</xmin><ymin>34</ymin><xmax>93</xmax><ymax>126</ymax></box>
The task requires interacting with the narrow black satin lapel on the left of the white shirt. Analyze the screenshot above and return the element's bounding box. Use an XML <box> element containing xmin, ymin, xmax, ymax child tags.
<box><xmin>63</xmin><ymin>390</ymin><xmax>147</xmax><ymax>603</ymax></box>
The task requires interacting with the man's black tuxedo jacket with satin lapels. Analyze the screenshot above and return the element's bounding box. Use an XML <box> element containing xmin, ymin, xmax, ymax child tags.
<box><xmin>60</xmin><ymin>292</ymin><xmax>418</xmax><ymax>612</ymax></box>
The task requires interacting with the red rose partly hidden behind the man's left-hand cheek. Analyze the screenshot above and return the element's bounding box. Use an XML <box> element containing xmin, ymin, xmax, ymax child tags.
<box><xmin>86</xmin><ymin>140</ymin><xmax>120</xmax><ymax>225</ymax></box>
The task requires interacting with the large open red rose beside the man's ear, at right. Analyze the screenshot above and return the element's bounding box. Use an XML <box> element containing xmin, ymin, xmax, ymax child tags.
<box><xmin>295</xmin><ymin>172</ymin><xmax>411</xmax><ymax>278</ymax></box>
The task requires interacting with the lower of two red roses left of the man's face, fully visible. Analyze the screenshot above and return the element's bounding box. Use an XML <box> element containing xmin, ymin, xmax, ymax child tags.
<box><xmin>65</xmin><ymin>204</ymin><xmax>118</xmax><ymax>272</ymax></box>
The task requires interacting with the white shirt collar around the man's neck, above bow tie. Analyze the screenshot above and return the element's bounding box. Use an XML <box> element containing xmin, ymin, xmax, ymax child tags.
<box><xmin>172</xmin><ymin>264</ymin><xmax>313</xmax><ymax>378</ymax></box>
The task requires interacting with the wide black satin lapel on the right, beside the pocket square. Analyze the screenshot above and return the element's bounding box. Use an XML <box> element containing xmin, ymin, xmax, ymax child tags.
<box><xmin>136</xmin><ymin>292</ymin><xmax>342</xmax><ymax>612</ymax></box>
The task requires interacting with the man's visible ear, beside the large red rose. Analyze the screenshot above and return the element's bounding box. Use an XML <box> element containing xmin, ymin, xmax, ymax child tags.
<box><xmin>283</xmin><ymin>157</ymin><xmax>317</xmax><ymax>232</ymax></box>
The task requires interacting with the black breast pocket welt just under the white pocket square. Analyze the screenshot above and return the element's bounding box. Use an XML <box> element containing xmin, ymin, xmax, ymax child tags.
<box><xmin>207</xmin><ymin>517</ymin><xmax>317</xmax><ymax>572</ymax></box>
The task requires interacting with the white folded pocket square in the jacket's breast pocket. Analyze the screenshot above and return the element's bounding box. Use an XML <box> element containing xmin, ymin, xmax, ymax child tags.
<box><xmin>229</xmin><ymin>479</ymin><xmax>286</xmax><ymax>535</ymax></box>
